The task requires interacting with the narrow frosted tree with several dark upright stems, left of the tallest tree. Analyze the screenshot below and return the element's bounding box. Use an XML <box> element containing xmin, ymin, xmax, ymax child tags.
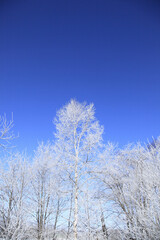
<box><xmin>29</xmin><ymin>143</ymin><xmax>63</xmax><ymax>240</ymax></box>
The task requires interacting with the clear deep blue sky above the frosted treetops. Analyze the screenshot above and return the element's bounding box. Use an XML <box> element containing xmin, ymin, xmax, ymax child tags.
<box><xmin>0</xmin><ymin>0</ymin><xmax>160</xmax><ymax>152</ymax></box>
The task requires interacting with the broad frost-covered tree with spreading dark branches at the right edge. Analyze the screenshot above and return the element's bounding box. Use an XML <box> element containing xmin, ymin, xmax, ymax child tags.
<box><xmin>98</xmin><ymin>141</ymin><xmax>160</xmax><ymax>240</ymax></box>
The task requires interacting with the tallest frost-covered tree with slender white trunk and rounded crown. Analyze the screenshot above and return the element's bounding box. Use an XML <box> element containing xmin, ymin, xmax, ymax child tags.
<box><xmin>54</xmin><ymin>100</ymin><xmax>103</xmax><ymax>240</ymax></box>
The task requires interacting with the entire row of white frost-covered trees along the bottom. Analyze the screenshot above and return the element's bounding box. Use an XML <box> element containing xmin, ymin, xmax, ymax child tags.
<box><xmin>0</xmin><ymin>100</ymin><xmax>160</xmax><ymax>240</ymax></box>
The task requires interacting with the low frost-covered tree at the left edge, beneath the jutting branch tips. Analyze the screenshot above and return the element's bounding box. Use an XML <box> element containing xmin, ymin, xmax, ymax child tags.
<box><xmin>0</xmin><ymin>154</ymin><xmax>29</xmax><ymax>240</ymax></box>
